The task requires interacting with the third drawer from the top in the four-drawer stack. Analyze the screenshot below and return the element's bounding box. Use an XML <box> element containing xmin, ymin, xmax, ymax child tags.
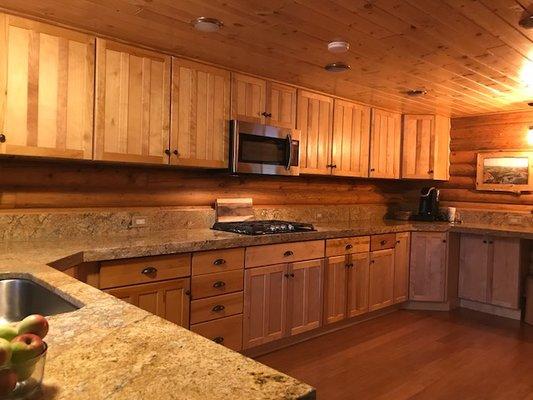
<box><xmin>191</xmin><ymin>292</ymin><xmax>243</xmax><ymax>324</ymax></box>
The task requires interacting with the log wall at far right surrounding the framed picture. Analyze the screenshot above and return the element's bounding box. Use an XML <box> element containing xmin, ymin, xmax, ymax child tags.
<box><xmin>440</xmin><ymin>111</ymin><xmax>533</xmax><ymax>211</ymax></box>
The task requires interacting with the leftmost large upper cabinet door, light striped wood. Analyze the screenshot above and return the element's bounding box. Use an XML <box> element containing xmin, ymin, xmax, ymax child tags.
<box><xmin>0</xmin><ymin>14</ymin><xmax>94</xmax><ymax>159</ymax></box>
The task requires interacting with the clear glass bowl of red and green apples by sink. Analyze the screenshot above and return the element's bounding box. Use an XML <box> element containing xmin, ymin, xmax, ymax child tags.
<box><xmin>0</xmin><ymin>314</ymin><xmax>48</xmax><ymax>400</ymax></box>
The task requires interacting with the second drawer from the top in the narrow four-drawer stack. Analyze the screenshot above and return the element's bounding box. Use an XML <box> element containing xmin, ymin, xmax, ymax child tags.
<box><xmin>191</xmin><ymin>270</ymin><xmax>244</xmax><ymax>299</ymax></box>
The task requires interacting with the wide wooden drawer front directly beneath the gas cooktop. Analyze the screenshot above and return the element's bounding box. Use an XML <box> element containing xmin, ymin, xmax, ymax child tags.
<box><xmin>245</xmin><ymin>240</ymin><xmax>324</xmax><ymax>268</ymax></box>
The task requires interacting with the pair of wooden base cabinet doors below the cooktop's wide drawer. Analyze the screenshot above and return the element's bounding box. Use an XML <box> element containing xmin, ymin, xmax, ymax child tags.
<box><xmin>243</xmin><ymin>259</ymin><xmax>323</xmax><ymax>349</ymax></box>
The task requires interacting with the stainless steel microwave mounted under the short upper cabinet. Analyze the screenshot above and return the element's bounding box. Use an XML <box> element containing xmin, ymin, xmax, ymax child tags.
<box><xmin>230</xmin><ymin>120</ymin><xmax>300</xmax><ymax>175</ymax></box>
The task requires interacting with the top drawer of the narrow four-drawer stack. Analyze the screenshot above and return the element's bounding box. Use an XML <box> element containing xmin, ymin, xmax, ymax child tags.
<box><xmin>192</xmin><ymin>247</ymin><xmax>244</xmax><ymax>275</ymax></box>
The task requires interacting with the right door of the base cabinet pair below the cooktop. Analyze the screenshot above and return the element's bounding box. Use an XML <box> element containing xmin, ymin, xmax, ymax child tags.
<box><xmin>287</xmin><ymin>260</ymin><xmax>324</xmax><ymax>335</ymax></box>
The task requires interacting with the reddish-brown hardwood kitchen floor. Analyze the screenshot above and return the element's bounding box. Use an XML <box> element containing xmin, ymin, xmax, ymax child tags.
<box><xmin>257</xmin><ymin>309</ymin><xmax>533</xmax><ymax>400</ymax></box>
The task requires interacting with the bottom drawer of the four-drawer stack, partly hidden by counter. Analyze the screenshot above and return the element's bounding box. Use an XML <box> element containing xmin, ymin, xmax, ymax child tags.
<box><xmin>191</xmin><ymin>314</ymin><xmax>242</xmax><ymax>351</ymax></box>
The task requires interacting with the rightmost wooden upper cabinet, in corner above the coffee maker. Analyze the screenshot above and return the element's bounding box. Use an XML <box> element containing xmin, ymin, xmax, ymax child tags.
<box><xmin>402</xmin><ymin>115</ymin><xmax>450</xmax><ymax>180</ymax></box>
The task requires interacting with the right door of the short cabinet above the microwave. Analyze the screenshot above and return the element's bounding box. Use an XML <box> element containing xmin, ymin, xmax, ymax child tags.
<box><xmin>266</xmin><ymin>82</ymin><xmax>296</xmax><ymax>129</ymax></box>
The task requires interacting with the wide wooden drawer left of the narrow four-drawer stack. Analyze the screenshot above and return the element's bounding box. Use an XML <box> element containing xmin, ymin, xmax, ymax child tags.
<box><xmin>99</xmin><ymin>253</ymin><xmax>191</xmax><ymax>289</ymax></box>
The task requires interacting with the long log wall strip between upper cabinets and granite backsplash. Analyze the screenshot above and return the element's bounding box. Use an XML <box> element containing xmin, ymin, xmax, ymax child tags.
<box><xmin>0</xmin><ymin>158</ymin><xmax>417</xmax><ymax>209</ymax></box>
